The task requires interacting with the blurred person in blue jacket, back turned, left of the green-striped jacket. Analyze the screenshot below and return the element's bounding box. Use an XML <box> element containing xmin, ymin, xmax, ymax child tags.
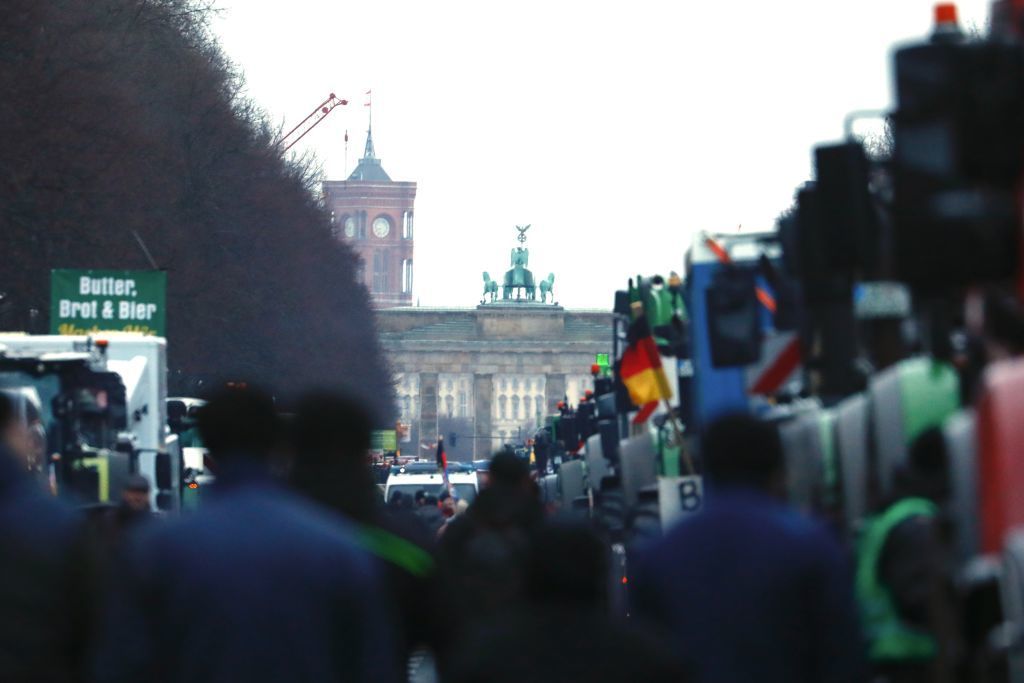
<box><xmin>96</xmin><ymin>388</ymin><xmax>395</xmax><ymax>683</ymax></box>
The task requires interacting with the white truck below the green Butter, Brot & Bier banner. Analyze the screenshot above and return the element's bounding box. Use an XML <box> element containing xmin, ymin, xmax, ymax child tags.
<box><xmin>0</xmin><ymin>332</ymin><xmax>181</xmax><ymax>510</ymax></box>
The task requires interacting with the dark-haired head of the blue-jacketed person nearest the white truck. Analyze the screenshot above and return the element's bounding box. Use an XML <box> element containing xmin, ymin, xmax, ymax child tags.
<box><xmin>198</xmin><ymin>387</ymin><xmax>281</xmax><ymax>462</ymax></box>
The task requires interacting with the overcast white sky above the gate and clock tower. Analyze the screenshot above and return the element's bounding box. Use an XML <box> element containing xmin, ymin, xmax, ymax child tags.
<box><xmin>214</xmin><ymin>0</ymin><xmax>988</xmax><ymax>308</ymax></box>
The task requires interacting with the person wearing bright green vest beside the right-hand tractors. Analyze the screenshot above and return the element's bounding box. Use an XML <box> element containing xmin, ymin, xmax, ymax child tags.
<box><xmin>855</xmin><ymin>428</ymin><xmax>953</xmax><ymax>683</ymax></box>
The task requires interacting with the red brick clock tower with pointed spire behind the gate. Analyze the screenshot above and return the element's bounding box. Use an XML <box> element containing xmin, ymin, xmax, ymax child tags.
<box><xmin>324</xmin><ymin>128</ymin><xmax>416</xmax><ymax>308</ymax></box>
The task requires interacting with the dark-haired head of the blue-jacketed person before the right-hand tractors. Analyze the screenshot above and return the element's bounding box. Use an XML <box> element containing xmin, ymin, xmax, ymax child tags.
<box><xmin>701</xmin><ymin>415</ymin><xmax>785</xmax><ymax>494</ymax></box>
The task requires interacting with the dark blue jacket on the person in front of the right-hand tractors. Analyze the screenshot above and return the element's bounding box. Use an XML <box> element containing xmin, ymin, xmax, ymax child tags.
<box><xmin>630</xmin><ymin>489</ymin><xmax>864</xmax><ymax>683</ymax></box>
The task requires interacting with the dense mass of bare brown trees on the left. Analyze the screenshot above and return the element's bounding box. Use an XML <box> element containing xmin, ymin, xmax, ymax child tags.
<box><xmin>0</xmin><ymin>0</ymin><xmax>393</xmax><ymax>420</ymax></box>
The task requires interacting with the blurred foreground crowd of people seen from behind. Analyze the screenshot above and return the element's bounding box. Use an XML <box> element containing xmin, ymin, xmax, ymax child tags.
<box><xmin>0</xmin><ymin>388</ymin><xmax>947</xmax><ymax>683</ymax></box>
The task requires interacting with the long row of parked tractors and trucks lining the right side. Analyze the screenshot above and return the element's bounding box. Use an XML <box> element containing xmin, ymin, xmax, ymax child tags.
<box><xmin>532</xmin><ymin>2</ymin><xmax>1024</xmax><ymax>681</ymax></box>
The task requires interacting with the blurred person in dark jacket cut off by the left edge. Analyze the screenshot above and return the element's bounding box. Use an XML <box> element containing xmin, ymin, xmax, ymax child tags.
<box><xmin>0</xmin><ymin>392</ymin><xmax>92</xmax><ymax>683</ymax></box>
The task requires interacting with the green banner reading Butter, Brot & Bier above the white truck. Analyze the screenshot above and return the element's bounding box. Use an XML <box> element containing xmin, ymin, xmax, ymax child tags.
<box><xmin>50</xmin><ymin>269</ymin><xmax>167</xmax><ymax>337</ymax></box>
